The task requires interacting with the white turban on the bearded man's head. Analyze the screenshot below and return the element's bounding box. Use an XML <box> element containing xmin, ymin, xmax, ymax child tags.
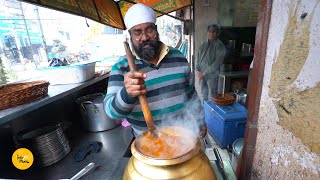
<box><xmin>124</xmin><ymin>4</ymin><xmax>156</xmax><ymax>29</ymax></box>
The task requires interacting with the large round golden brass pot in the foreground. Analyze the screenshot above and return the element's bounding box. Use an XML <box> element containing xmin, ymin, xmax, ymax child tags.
<box><xmin>123</xmin><ymin>127</ymin><xmax>216</xmax><ymax>180</ymax></box>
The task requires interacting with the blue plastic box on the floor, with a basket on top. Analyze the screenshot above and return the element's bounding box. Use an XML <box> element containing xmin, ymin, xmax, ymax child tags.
<box><xmin>203</xmin><ymin>101</ymin><xmax>248</xmax><ymax>148</ymax></box>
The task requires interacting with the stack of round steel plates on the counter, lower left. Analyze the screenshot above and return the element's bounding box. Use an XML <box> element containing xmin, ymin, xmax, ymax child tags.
<box><xmin>15</xmin><ymin>124</ymin><xmax>70</xmax><ymax>167</ymax></box>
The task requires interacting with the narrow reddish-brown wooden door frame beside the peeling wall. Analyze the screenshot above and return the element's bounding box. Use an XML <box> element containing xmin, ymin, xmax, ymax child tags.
<box><xmin>238</xmin><ymin>0</ymin><xmax>273</xmax><ymax>179</ymax></box>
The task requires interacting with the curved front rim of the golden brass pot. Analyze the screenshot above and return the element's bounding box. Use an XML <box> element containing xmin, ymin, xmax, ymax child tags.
<box><xmin>131</xmin><ymin>139</ymin><xmax>200</xmax><ymax>166</ymax></box>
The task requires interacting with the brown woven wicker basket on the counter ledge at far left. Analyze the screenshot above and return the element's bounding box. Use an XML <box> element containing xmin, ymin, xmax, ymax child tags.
<box><xmin>0</xmin><ymin>81</ymin><xmax>49</xmax><ymax>110</ymax></box>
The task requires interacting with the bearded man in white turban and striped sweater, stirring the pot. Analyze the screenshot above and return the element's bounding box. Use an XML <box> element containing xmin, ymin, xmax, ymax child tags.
<box><xmin>104</xmin><ymin>4</ymin><xmax>207</xmax><ymax>137</ymax></box>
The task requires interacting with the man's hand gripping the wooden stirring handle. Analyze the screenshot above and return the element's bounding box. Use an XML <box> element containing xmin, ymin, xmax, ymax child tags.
<box><xmin>124</xmin><ymin>71</ymin><xmax>147</xmax><ymax>97</ymax></box>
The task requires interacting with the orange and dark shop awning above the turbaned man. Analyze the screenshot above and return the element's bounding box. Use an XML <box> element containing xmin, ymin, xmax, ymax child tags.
<box><xmin>20</xmin><ymin>0</ymin><xmax>191</xmax><ymax>29</ymax></box>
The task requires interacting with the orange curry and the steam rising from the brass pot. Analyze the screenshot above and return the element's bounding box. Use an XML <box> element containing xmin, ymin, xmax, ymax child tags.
<box><xmin>137</xmin><ymin>94</ymin><xmax>204</xmax><ymax>159</ymax></box>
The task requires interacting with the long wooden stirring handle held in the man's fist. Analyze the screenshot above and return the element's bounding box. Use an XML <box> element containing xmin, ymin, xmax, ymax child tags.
<box><xmin>124</xmin><ymin>41</ymin><xmax>155</xmax><ymax>130</ymax></box>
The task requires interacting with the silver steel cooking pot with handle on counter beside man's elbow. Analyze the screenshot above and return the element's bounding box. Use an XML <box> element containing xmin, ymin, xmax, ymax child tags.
<box><xmin>76</xmin><ymin>93</ymin><xmax>121</xmax><ymax>132</ymax></box>
